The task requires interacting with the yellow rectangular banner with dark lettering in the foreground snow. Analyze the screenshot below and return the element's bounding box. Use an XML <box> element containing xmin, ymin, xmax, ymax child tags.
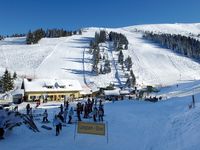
<box><xmin>78</xmin><ymin>121</ymin><xmax>105</xmax><ymax>136</ymax></box>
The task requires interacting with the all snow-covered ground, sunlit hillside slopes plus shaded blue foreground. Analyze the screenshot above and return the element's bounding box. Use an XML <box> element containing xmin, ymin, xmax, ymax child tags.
<box><xmin>0</xmin><ymin>24</ymin><xmax>200</xmax><ymax>150</ymax></box>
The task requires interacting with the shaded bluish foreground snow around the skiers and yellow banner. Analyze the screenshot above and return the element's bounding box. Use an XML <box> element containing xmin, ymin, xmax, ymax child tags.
<box><xmin>0</xmin><ymin>95</ymin><xmax>200</xmax><ymax>150</ymax></box>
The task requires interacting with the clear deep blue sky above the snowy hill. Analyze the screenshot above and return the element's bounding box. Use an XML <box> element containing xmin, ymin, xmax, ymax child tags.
<box><xmin>0</xmin><ymin>0</ymin><xmax>200</xmax><ymax>35</ymax></box>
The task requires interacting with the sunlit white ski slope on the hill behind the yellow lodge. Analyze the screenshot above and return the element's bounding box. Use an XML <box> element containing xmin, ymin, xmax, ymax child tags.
<box><xmin>0</xmin><ymin>24</ymin><xmax>200</xmax><ymax>94</ymax></box>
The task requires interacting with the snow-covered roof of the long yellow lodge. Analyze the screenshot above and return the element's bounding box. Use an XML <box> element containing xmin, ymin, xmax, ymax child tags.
<box><xmin>24</xmin><ymin>79</ymin><xmax>82</xmax><ymax>92</ymax></box>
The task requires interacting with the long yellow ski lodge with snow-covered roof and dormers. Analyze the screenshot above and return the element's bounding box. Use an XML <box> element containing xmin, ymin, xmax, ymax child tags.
<box><xmin>22</xmin><ymin>79</ymin><xmax>82</xmax><ymax>101</ymax></box>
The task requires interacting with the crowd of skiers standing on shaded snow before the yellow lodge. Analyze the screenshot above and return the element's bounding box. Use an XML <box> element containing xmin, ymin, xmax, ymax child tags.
<box><xmin>26</xmin><ymin>98</ymin><xmax>104</xmax><ymax>136</ymax></box>
